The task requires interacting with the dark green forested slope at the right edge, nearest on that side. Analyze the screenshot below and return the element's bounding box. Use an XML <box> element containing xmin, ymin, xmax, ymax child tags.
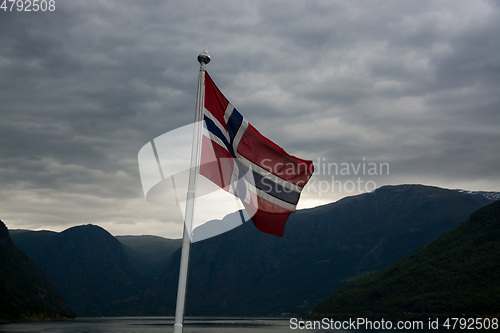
<box><xmin>313</xmin><ymin>201</ymin><xmax>500</xmax><ymax>317</ymax></box>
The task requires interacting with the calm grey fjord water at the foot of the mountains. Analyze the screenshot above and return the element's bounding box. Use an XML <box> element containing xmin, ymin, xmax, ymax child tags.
<box><xmin>0</xmin><ymin>317</ymin><xmax>450</xmax><ymax>333</ymax></box>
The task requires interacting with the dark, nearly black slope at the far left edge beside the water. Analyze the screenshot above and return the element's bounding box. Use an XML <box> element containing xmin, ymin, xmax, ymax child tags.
<box><xmin>0</xmin><ymin>221</ymin><xmax>74</xmax><ymax>322</ymax></box>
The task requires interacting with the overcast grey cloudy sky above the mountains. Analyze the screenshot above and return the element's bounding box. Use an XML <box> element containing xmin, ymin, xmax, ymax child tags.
<box><xmin>0</xmin><ymin>0</ymin><xmax>500</xmax><ymax>237</ymax></box>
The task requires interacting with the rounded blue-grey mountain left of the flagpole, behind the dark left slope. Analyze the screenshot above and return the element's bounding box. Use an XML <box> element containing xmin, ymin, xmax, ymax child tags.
<box><xmin>13</xmin><ymin>224</ymin><xmax>148</xmax><ymax>316</ymax></box>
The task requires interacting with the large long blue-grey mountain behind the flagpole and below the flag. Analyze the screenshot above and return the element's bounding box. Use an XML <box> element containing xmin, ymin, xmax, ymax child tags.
<box><xmin>127</xmin><ymin>185</ymin><xmax>491</xmax><ymax>316</ymax></box>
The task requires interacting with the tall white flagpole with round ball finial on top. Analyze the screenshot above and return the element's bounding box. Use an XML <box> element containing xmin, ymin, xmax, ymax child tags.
<box><xmin>174</xmin><ymin>50</ymin><xmax>210</xmax><ymax>333</ymax></box>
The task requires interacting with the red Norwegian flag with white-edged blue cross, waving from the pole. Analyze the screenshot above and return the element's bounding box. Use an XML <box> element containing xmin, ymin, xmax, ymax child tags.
<box><xmin>200</xmin><ymin>73</ymin><xmax>314</xmax><ymax>236</ymax></box>
